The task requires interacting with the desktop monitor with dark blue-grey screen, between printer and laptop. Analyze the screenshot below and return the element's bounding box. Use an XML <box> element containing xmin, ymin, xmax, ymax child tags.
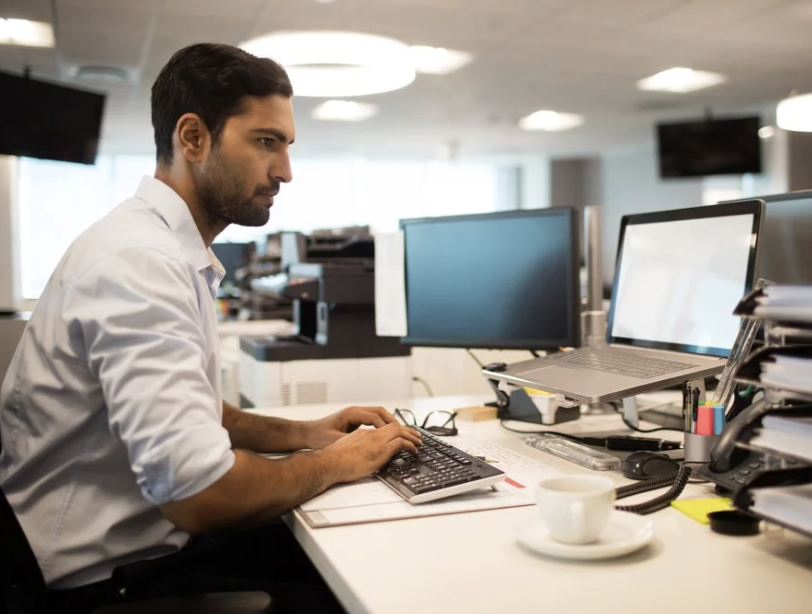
<box><xmin>400</xmin><ymin>208</ymin><xmax>580</xmax><ymax>350</ymax></box>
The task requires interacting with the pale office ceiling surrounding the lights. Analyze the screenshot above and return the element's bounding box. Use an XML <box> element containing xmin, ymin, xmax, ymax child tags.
<box><xmin>7</xmin><ymin>0</ymin><xmax>812</xmax><ymax>155</ymax></box>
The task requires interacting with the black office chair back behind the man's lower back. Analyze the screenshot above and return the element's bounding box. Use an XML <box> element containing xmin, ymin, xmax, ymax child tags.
<box><xmin>0</xmin><ymin>489</ymin><xmax>46</xmax><ymax>614</ymax></box>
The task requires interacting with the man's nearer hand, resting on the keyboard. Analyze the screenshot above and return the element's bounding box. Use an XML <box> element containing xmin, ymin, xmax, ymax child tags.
<box><xmin>323</xmin><ymin>422</ymin><xmax>423</xmax><ymax>482</ymax></box>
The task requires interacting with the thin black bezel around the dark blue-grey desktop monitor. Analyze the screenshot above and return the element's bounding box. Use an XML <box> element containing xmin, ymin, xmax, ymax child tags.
<box><xmin>400</xmin><ymin>207</ymin><xmax>581</xmax><ymax>351</ymax></box>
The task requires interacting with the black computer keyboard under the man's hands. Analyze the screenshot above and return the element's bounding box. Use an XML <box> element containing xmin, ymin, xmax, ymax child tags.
<box><xmin>375</xmin><ymin>427</ymin><xmax>505</xmax><ymax>503</ymax></box>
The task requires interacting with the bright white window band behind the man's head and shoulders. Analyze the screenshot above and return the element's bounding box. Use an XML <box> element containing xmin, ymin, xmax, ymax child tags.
<box><xmin>18</xmin><ymin>155</ymin><xmax>499</xmax><ymax>299</ymax></box>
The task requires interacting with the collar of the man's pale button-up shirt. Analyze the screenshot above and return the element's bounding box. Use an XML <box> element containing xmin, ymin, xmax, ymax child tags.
<box><xmin>135</xmin><ymin>175</ymin><xmax>225</xmax><ymax>285</ymax></box>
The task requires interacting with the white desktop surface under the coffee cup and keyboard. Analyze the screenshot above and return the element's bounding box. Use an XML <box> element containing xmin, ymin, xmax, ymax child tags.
<box><xmin>251</xmin><ymin>397</ymin><xmax>812</xmax><ymax>614</ymax></box>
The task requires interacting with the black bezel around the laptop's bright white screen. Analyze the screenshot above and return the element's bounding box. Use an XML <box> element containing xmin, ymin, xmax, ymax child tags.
<box><xmin>606</xmin><ymin>198</ymin><xmax>764</xmax><ymax>358</ymax></box>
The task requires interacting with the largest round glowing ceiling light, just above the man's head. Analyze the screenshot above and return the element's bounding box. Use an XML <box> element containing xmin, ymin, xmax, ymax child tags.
<box><xmin>240</xmin><ymin>31</ymin><xmax>415</xmax><ymax>98</ymax></box>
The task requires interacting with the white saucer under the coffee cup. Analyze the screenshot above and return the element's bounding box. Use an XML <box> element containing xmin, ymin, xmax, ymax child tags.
<box><xmin>518</xmin><ymin>511</ymin><xmax>654</xmax><ymax>561</ymax></box>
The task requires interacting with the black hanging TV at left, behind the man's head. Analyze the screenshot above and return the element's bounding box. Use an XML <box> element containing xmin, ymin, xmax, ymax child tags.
<box><xmin>0</xmin><ymin>72</ymin><xmax>105</xmax><ymax>164</ymax></box>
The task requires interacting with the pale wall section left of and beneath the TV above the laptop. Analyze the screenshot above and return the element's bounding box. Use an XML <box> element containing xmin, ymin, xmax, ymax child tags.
<box><xmin>600</xmin><ymin>144</ymin><xmax>702</xmax><ymax>284</ymax></box>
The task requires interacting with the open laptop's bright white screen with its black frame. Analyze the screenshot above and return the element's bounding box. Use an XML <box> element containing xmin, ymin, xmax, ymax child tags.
<box><xmin>607</xmin><ymin>200</ymin><xmax>763</xmax><ymax>357</ymax></box>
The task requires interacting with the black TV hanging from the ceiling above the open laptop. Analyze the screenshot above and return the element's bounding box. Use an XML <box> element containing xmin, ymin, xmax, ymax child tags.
<box><xmin>657</xmin><ymin>117</ymin><xmax>761</xmax><ymax>178</ymax></box>
